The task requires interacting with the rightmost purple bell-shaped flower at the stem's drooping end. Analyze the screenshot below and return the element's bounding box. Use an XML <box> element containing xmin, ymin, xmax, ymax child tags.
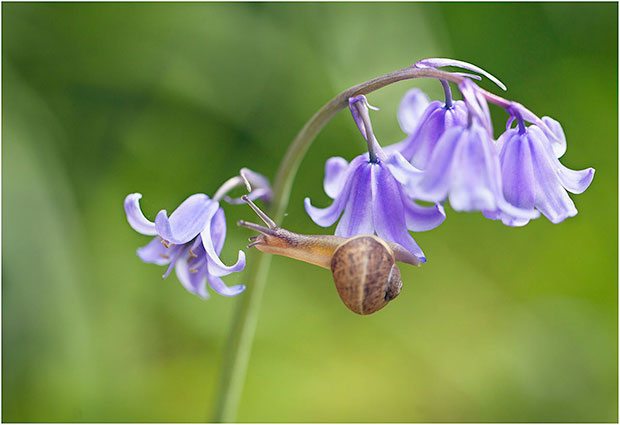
<box><xmin>491</xmin><ymin>105</ymin><xmax>594</xmax><ymax>226</ymax></box>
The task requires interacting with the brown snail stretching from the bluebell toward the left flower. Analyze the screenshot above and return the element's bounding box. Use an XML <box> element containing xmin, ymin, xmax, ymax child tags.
<box><xmin>237</xmin><ymin>196</ymin><xmax>420</xmax><ymax>315</ymax></box>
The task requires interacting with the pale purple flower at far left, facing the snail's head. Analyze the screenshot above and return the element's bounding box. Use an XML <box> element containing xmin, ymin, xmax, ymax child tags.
<box><xmin>124</xmin><ymin>193</ymin><xmax>245</xmax><ymax>298</ymax></box>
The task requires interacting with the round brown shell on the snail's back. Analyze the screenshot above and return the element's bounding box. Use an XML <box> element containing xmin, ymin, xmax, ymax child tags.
<box><xmin>331</xmin><ymin>236</ymin><xmax>403</xmax><ymax>314</ymax></box>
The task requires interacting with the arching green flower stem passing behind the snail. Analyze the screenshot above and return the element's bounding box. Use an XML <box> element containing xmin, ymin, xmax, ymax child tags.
<box><xmin>213</xmin><ymin>67</ymin><xmax>463</xmax><ymax>422</ymax></box>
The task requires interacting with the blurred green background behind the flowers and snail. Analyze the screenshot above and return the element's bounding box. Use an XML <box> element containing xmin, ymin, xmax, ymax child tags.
<box><xmin>2</xmin><ymin>3</ymin><xmax>618</xmax><ymax>422</ymax></box>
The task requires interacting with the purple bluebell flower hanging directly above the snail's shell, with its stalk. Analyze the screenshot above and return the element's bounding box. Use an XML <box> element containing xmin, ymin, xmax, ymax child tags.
<box><xmin>304</xmin><ymin>96</ymin><xmax>445</xmax><ymax>262</ymax></box>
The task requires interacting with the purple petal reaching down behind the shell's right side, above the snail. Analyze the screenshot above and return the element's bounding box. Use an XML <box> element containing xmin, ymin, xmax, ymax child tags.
<box><xmin>371</xmin><ymin>164</ymin><xmax>426</xmax><ymax>263</ymax></box>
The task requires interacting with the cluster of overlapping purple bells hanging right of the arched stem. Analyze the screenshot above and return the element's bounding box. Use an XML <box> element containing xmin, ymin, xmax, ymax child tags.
<box><xmin>305</xmin><ymin>59</ymin><xmax>594</xmax><ymax>262</ymax></box>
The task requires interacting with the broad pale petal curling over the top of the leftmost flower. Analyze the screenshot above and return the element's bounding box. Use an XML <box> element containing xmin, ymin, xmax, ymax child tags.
<box><xmin>155</xmin><ymin>194</ymin><xmax>219</xmax><ymax>244</ymax></box>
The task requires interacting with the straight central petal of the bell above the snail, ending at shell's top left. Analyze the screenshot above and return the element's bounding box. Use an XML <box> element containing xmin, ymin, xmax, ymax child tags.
<box><xmin>335</xmin><ymin>163</ymin><xmax>379</xmax><ymax>238</ymax></box>
